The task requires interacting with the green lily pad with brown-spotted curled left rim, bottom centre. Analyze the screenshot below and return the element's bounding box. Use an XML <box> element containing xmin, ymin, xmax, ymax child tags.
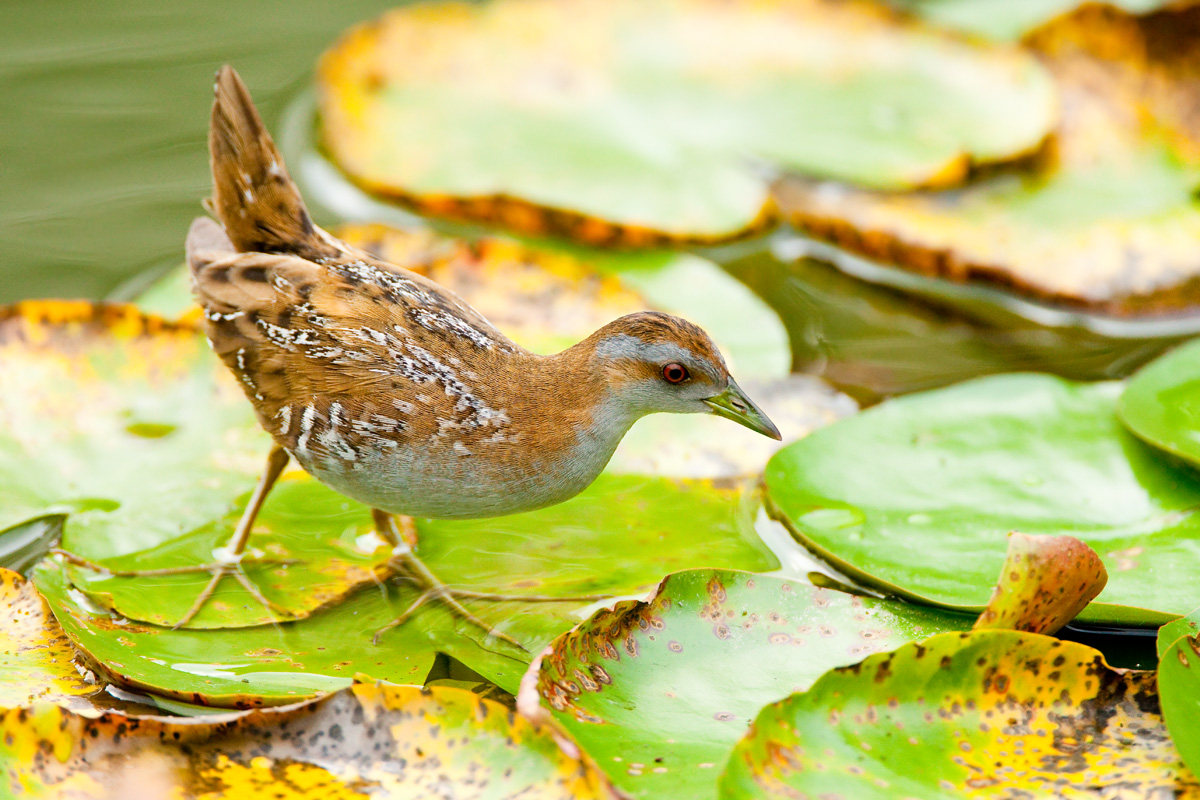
<box><xmin>518</xmin><ymin>570</ymin><xmax>971</xmax><ymax>798</ymax></box>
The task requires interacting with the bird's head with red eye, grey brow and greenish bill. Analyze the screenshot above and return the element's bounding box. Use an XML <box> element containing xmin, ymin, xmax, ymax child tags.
<box><xmin>590</xmin><ymin>312</ymin><xmax>781</xmax><ymax>439</ymax></box>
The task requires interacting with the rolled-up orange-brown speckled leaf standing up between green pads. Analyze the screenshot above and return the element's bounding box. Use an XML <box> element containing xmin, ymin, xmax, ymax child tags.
<box><xmin>974</xmin><ymin>534</ymin><xmax>1109</xmax><ymax>636</ymax></box>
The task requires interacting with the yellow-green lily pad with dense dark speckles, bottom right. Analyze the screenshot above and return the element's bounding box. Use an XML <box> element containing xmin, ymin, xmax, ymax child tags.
<box><xmin>721</xmin><ymin>631</ymin><xmax>1200</xmax><ymax>800</ymax></box>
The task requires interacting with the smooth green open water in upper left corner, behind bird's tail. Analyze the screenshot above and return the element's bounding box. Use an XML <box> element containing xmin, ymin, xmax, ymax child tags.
<box><xmin>0</xmin><ymin>0</ymin><xmax>401</xmax><ymax>302</ymax></box>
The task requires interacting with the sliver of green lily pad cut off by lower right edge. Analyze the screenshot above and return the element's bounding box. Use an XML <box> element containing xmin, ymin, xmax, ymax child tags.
<box><xmin>1158</xmin><ymin>609</ymin><xmax>1200</xmax><ymax>771</ymax></box>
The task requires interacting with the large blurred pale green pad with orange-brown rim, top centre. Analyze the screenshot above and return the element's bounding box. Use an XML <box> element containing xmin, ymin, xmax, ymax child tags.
<box><xmin>318</xmin><ymin>0</ymin><xmax>1057</xmax><ymax>246</ymax></box>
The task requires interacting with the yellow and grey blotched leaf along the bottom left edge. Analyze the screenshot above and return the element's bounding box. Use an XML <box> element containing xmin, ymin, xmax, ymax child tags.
<box><xmin>0</xmin><ymin>684</ymin><xmax>617</xmax><ymax>800</ymax></box>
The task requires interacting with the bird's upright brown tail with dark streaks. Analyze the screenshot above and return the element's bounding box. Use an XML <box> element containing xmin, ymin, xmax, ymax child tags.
<box><xmin>209</xmin><ymin>65</ymin><xmax>332</xmax><ymax>258</ymax></box>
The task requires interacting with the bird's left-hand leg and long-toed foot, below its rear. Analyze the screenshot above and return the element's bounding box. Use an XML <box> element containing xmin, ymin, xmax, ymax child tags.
<box><xmin>53</xmin><ymin>445</ymin><xmax>300</xmax><ymax>630</ymax></box>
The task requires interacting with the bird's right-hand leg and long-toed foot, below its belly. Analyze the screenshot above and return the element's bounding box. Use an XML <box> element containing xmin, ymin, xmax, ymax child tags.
<box><xmin>371</xmin><ymin>509</ymin><xmax>607</xmax><ymax>650</ymax></box>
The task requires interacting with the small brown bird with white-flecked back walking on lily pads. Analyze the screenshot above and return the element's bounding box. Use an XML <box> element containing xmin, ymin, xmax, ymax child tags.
<box><xmin>64</xmin><ymin>65</ymin><xmax>781</xmax><ymax>646</ymax></box>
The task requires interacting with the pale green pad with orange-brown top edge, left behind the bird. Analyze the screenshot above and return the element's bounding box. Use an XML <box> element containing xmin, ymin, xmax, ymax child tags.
<box><xmin>0</xmin><ymin>301</ymin><xmax>259</xmax><ymax>559</ymax></box>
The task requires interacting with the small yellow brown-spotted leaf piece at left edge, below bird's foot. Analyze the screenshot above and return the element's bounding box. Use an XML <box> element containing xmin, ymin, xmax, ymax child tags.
<box><xmin>0</xmin><ymin>570</ymin><xmax>100</xmax><ymax>710</ymax></box>
